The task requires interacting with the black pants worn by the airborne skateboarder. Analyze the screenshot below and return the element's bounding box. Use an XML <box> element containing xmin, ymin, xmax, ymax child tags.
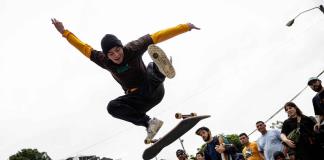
<box><xmin>107</xmin><ymin>62</ymin><xmax>165</xmax><ymax>127</ymax></box>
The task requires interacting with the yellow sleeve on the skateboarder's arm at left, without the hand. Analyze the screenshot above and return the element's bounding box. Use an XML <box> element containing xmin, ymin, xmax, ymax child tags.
<box><xmin>63</xmin><ymin>30</ymin><xmax>93</xmax><ymax>58</ymax></box>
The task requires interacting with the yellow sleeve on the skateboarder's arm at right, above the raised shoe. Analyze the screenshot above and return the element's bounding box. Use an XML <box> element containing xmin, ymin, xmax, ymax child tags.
<box><xmin>151</xmin><ymin>24</ymin><xmax>190</xmax><ymax>44</ymax></box>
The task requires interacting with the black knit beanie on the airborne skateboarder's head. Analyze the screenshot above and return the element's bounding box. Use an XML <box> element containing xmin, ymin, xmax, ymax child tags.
<box><xmin>101</xmin><ymin>34</ymin><xmax>123</xmax><ymax>54</ymax></box>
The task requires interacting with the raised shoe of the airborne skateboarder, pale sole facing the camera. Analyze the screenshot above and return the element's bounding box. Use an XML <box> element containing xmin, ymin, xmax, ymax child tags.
<box><xmin>148</xmin><ymin>44</ymin><xmax>175</xmax><ymax>79</ymax></box>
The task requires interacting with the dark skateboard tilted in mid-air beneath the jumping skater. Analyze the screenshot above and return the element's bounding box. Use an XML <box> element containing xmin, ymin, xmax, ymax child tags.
<box><xmin>142</xmin><ymin>113</ymin><xmax>210</xmax><ymax>160</ymax></box>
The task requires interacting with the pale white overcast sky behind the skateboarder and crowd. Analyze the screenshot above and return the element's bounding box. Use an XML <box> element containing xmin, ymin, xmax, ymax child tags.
<box><xmin>0</xmin><ymin>0</ymin><xmax>324</xmax><ymax>160</ymax></box>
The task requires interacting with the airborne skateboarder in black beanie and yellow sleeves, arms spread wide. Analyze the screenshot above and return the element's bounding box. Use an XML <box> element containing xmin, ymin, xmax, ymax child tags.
<box><xmin>52</xmin><ymin>19</ymin><xmax>199</xmax><ymax>142</ymax></box>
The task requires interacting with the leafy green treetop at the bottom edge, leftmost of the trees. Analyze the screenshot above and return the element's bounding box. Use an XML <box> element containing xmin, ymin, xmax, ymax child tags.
<box><xmin>9</xmin><ymin>149</ymin><xmax>51</xmax><ymax>160</ymax></box>
